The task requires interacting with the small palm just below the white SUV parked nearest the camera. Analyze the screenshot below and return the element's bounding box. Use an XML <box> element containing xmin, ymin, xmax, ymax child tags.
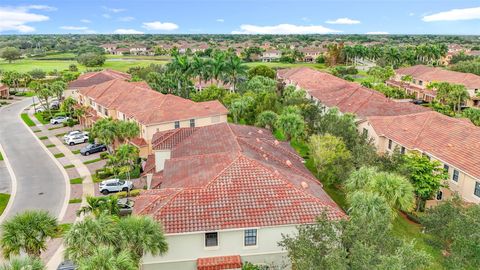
<box><xmin>77</xmin><ymin>196</ymin><xmax>120</xmax><ymax>217</ymax></box>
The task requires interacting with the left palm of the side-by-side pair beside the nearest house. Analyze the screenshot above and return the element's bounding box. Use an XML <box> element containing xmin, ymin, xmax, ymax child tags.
<box><xmin>63</xmin><ymin>215</ymin><xmax>121</xmax><ymax>263</ymax></box>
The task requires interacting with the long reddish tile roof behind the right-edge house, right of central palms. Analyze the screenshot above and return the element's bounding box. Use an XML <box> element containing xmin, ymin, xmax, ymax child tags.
<box><xmin>277</xmin><ymin>67</ymin><xmax>429</xmax><ymax>118</ymax></box>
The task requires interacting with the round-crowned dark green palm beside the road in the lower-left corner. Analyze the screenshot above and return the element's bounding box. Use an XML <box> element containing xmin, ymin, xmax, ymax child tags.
<box><xmin>0</xmin><ymin>211</ymin><xmax>58</xmax><ymax>258</ymax></box>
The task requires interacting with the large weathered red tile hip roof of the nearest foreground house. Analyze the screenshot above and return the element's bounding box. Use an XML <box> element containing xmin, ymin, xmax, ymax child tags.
<box><xmin>134</xmin><ymin>123</ymin><xmax>345</xmax><ymax>233</ymax></box>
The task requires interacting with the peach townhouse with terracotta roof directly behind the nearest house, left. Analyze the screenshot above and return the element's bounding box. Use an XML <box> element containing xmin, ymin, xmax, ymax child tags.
<box><xmin>75</xmin><ymin>79</ymin><xmax>228</xmax><ymax>157</ymax></box>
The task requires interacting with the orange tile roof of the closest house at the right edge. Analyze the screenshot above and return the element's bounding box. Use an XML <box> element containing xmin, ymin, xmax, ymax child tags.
<box><xmin>367</xmin><ymin>111</ymin><xmax>480</xmax><ymax>179</ymax></box>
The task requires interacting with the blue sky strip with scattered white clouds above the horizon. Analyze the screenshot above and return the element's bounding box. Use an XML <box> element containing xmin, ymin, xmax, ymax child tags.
<box><xmin>0</xmin><ymin>0</ymin><xmax>480</xmax><ymax>35</ymax></box>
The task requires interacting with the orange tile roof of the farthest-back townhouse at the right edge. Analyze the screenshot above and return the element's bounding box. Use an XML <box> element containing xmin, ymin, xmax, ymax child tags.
<box><xmin>395</xmin><ymin>65</ymin><xmax>480</xmax><ymax>89</ymax></box>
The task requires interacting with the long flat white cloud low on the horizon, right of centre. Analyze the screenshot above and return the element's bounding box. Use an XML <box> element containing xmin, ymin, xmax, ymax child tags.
<box><xmin>232</xmin><ymin>23</ymin><xmax>341</xmax><ymax>35</ymax></box>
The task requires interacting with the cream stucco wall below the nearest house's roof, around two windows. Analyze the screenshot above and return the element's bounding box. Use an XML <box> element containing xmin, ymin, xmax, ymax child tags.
<box><xmin>142</xmin><ymin>226</ymin><xmax>296</xmax><ymax>270</ymax></box>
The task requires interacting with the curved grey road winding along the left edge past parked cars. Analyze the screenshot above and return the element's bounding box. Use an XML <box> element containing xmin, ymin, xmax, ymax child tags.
<box><xmin>0</xmin><ymin>98</ymin><xmax>66</xmax><ymax>219</ymax></box>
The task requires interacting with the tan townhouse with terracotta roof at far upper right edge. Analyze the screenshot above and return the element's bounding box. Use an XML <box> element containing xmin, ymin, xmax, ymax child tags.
<box><xmin>386</xmin><ymin>65</ymin><xmax>480</xmax><ymax>107</ymax></box>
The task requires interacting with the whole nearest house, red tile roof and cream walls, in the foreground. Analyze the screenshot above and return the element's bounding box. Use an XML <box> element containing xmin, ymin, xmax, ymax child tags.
<box><xmin>134</xmin><ymin>123</ymin><xmax>346</xmax><ymax>270</ymax></box>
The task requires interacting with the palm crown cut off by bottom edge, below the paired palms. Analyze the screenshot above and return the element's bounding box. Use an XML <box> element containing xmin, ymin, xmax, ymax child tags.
<box><xmin>77</xmin><ymin>246</ymin><xmax>138</xmax><ymax>270</ymax></box>
